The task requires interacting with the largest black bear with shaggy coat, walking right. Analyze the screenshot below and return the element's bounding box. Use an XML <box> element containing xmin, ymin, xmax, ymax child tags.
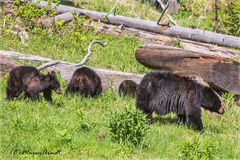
<box><xmin>136</xmin><ymin>72</ymin><xmax>224</xmax><ymax>131</ymax></box>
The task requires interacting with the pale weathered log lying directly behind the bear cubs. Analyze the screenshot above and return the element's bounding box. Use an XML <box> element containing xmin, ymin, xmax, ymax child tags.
<box><xmin>0</xmin><ymin>50</ymin><xmax>143</xmax><ymax>91</ymax></box>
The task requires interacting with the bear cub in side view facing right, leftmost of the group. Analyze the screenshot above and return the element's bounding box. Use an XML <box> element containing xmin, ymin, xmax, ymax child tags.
<box><xmin>6</xmin><ymin>66</ymin><xmax>61</xmax><ymax>102</ymax></box>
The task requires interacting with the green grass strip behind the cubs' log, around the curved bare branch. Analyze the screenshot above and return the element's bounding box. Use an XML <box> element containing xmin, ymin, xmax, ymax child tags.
<box><xmin>0</xmin><ymin>20</ymin><xmax>148</xmax><ymax>73</ymax></box>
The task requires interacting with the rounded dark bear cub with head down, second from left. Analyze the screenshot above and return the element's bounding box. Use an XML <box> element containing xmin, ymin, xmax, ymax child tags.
<box><xmin>66</xmin><ymin>67</ymin><xmax>102</xmax><ymax>97</ymax></box>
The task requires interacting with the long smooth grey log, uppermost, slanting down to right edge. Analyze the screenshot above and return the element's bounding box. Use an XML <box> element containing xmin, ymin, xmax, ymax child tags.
<box><xmin>16</xmin><ymin>0</ymin><xmax>240</xmax><ymax>48</ymax></box>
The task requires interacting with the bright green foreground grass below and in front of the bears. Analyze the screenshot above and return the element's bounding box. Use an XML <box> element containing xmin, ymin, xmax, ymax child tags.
<box><xmin>0</xmin><ymin>77</ymin><xmax>240</xmax><ymax>159</ymax></box>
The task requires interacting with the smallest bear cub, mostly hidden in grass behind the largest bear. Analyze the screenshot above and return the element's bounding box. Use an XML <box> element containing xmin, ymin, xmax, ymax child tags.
<box><xmin>118</xmin><ymin>80</ymin><xmax>138</xmax><ymax>97</ymax></box>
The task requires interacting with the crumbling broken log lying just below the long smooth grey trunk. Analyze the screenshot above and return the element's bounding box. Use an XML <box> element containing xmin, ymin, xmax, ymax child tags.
<box><xmin>41</xmin><ymin>12</ymin><xmax>240</xmax><ymax>59</ymax></box>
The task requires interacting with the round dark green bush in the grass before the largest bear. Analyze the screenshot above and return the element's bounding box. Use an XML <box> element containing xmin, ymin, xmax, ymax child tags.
<box><xmin>109</xmin><ymin>107</ymin><xmax>149</xmax><ymax>145</ymax></box>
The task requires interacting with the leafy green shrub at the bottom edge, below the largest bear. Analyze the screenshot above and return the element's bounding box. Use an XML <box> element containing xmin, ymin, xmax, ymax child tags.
<box><xmin>180</xmin><ymin>138</ymin><xmax>217</xmax><ymax>160</ymax></box>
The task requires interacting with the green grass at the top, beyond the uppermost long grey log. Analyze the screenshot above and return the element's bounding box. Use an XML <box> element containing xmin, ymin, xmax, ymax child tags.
<box><xmin>69</xmin><ymin>0</ymin><xmax>213</xmax><ymax>31</ymax></box>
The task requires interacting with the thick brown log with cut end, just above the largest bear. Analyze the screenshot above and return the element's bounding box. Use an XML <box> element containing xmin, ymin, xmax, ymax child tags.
<box><xmin>135</xmin><ymin>44</ymin><xmax>240</xmax><ymax>95</ymax></box>
